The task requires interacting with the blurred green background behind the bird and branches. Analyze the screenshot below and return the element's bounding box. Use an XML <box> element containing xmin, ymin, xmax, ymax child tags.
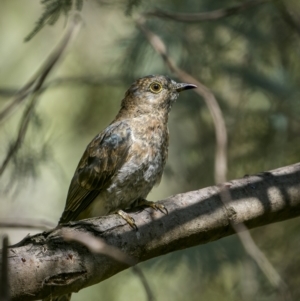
<box><xmin>0</xmin><ymin>0</ymin><xmax>300</xmax><ymax>301</ymax></box>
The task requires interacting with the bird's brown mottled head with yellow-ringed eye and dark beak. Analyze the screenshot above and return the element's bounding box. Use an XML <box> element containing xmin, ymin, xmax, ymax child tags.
<box><xmin>122</xmin><ymin>75</ymin><xmax>196</xmax><ymax>114</ymax></box>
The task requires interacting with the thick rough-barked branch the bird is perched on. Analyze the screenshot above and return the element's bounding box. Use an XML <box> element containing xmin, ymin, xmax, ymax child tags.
<box><xmin>4</xmin><ymin>164</ymin><xmax>300</xmax><ymax>301</ymax></box>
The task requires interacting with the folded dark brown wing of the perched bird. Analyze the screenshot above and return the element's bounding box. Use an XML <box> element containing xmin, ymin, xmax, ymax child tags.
<box><xmin>59</xmin><ymin>121</ymin><xmax>132</xmax><ymax>223</ymax></box>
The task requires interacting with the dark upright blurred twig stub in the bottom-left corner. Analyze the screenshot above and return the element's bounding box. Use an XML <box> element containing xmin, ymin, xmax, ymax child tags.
<box><xmin>0</xmin><ymin>235</ymin><xmax>10</xmax><ymax>301</ymax></box>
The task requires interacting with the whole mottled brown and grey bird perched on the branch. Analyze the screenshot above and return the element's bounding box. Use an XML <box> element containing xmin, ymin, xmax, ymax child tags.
<box><xmin>59</xmin><ymin>75</ymin><xmax>196</xmax><ymax>228</ymax></box>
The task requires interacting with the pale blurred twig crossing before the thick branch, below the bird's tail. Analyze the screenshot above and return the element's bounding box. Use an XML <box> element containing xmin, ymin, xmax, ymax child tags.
<box><xmin>63</xmin><ymin>231</ymin><xmax>155</xmax><ymax>301</ymax></box>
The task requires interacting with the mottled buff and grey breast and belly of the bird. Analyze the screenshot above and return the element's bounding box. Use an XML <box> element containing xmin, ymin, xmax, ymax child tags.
<box><xmin>90</xmin><ymin>118</ymin><xmax>168</xmax><ymax>215</ymax></box>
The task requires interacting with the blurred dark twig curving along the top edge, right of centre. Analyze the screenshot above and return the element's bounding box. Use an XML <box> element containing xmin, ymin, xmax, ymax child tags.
<box><xmin>143</xmin><ymin>0</ymin><xmax>270</xmax><ymax>23</ymax></box>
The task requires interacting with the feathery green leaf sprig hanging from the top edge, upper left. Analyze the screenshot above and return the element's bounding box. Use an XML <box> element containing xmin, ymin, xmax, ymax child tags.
<box><xmin>25</xmin><ymin>0</ymin><xmax>83</xmax><ymax>42</ymax></box>
